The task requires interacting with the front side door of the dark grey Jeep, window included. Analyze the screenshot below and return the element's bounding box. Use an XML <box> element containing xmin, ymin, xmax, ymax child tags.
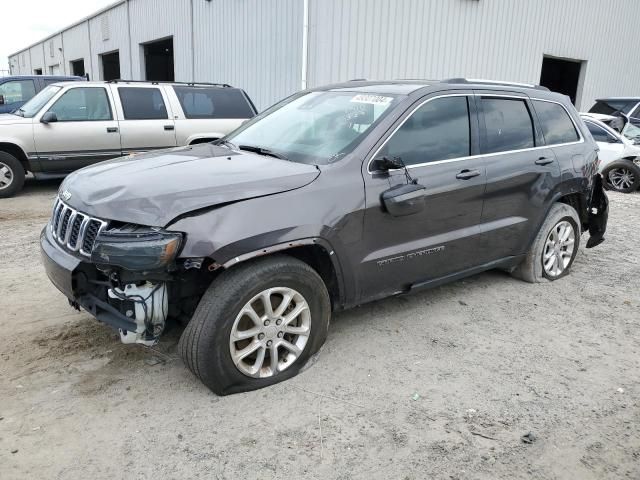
<box><xmin>358</xmin><ymin>92</ymin><xmax>486</xmax><ymax>300</ymax></box>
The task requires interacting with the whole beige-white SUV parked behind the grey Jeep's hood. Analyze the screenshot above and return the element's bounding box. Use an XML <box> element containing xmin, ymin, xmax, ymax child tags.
<box><xmin>0</xmin><ymin>81</ymin><xmax>257</xmax><ymax>197</ymax></box>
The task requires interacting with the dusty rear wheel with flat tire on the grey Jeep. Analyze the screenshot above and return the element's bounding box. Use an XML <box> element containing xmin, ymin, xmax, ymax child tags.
<box><xmin>511</xmin><ymin>203</ymin><xmax>581</xmax><ymax>283</ymax></box>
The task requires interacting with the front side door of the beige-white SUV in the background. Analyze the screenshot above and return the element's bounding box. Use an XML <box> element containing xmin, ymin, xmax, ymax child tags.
<box><xmin>33</xmin><ymin>85</ymin><xmax>121</xmax><ymax>173</ymax></box>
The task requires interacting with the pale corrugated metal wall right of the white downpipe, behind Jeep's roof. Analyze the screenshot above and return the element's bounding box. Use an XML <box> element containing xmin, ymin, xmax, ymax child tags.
<box><xmin>309</xmin><ymin>0</ymin><xmax>640</xmax><ymax>108</ymax></box>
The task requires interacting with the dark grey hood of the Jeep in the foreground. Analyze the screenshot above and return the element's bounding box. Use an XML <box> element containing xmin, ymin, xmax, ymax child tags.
<box><xmin>60</xmin><ymin>144</ymin><xmax>320</xmax><ymax>227</ymax></box>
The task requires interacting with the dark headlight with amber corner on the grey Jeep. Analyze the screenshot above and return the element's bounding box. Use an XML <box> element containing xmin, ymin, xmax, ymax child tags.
<box><xmin>91</xmin><ymin>228</ymin><xmax>182</xmax><ymax>270</ymax></box>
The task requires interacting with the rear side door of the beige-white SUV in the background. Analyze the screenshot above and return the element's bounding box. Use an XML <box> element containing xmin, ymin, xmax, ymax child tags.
<box><xmin>112</xmin><ymin>84</ymin><xmax>176</xmax><ymax>154</ymax></box>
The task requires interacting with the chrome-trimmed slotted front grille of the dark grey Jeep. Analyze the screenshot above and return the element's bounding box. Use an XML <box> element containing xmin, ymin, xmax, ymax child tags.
<box><xmin>51</xmin><ymin>199</ymin><xmax>107</xmax><ymax>257</ymax></box>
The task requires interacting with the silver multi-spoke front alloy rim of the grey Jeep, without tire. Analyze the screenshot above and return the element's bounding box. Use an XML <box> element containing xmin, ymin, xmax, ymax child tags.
<box><xmin>229</xmin><ymin>287</ymin><xmax>311</xmax><ymax>378</ymax></box>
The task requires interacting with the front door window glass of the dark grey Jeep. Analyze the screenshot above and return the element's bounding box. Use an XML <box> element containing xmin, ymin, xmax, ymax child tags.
<box><xmin>379</xmin><ymin>96</ymin><xmax>471</xmax><ymax>166</ymax></box>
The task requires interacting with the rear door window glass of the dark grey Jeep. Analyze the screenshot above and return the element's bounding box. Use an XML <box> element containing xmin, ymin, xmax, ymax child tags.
<box><xmin>481</xmin><ymin>97</ymin><xmax>535</xmax><ymax>153</ymax></box>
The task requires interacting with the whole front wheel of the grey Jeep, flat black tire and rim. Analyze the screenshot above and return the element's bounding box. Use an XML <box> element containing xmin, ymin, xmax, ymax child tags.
<box><xmin>179</xmin><ymin>255</ymin><xmax>331</xmax><ymax>395</ymax></box>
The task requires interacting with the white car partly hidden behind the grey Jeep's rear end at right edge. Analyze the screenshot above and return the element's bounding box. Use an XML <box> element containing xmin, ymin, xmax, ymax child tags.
<box><xmin>581</xmin><ymin>113</ymin><xmax>640</xmax><ymax>193</ymax></box>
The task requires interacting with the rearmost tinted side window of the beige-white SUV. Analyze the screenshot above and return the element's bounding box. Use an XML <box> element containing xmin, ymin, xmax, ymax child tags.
<box><xmin>173</xmin><ymin>86</ymin><xmax>255</xmax><ymax>119</ymax></box>
